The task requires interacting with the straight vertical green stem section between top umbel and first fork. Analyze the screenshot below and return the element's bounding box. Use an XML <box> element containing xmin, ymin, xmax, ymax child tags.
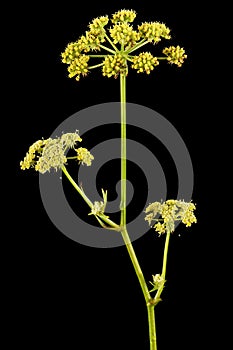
<box><xmin>120</xmin><ymin>74</ymin><xmax>126</xmax><ymax>228</ymax></box>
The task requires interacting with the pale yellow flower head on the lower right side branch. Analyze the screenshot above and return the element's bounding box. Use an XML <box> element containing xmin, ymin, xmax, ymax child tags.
<box><xmin>145</xmin><ymin>199</ymin><xmax>197</xmax><ymax>235</ymax></box>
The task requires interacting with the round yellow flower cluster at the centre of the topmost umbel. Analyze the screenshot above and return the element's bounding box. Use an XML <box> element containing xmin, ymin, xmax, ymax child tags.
<box><xmin>110</xmin><ymin>22</ymin><xmax>140</xmax><ymax>50</ymax></box>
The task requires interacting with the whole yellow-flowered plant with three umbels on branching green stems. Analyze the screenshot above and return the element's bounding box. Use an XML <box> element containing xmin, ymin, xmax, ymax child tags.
<box><xmin>20</xmin><ymin>10</ymin><xmax>196</xmax><ymax>350</ymax></box>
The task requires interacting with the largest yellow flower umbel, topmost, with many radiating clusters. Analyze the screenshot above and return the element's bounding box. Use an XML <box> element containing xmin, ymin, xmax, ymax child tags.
<box><xmin>61</xmin><ymin>10</ymin><xmax>187</xmax><ymax>81</ymax></box>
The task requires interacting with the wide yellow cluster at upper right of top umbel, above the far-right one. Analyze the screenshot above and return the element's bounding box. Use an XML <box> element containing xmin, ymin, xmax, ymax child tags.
<box><xmin>138</xmin><ymin>22</ymin><xmax>171</xmax><ymax>44</ymax></box>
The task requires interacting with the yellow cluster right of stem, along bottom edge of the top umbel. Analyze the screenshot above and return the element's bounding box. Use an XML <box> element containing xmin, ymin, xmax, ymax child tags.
<box><xmin>131</xmin><ymin>52</ymin><xmax>159</xmax><ymax>74</ymax></box>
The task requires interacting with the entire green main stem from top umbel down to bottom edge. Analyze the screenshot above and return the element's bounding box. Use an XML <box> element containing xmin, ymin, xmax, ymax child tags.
<box><xmin>120</xmin><ymin>74</ymin><xmax>157</xmax><ymax>350</ymax></box>
